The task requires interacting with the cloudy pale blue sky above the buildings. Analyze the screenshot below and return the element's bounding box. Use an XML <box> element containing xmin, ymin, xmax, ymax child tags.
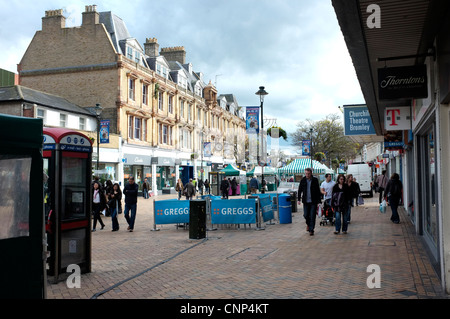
<box><xmin>0</xmin><ymin>0</ymin><xmax>364</xmax><ymax>155</ymax></box>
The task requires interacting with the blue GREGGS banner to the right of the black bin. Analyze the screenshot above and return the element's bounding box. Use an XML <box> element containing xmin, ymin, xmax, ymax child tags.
<box><xmin>211</xmin><ymin>199</ymin><xmax>256</xmax><ymax>224</ymax></box>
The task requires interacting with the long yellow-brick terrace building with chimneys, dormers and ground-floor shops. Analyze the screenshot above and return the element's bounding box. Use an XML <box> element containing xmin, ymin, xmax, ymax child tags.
<box><xmin>18</xmin><ymin>5</ymin><xmax>245</xmax><ymax>194</ymax></box>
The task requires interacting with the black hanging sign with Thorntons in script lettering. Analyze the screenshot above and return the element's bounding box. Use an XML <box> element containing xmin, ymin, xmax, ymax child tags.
<box><xmin>378</xmin><ymin>64</ymin><xmax>428</xmax><ymax>100</ymax></box>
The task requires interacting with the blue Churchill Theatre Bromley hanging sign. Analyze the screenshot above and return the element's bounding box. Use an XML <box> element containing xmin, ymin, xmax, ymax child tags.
<box><xmin>344</xmin><ymin>105</ymin><xmax>376</xmax><ymax>136</ymax></box>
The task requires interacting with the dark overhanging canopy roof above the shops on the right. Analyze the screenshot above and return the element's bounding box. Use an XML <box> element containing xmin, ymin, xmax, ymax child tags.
<box><xmin>332</xmin><ymin>0</ymin><xmax>450</xmax><ymax>135</ymax></box>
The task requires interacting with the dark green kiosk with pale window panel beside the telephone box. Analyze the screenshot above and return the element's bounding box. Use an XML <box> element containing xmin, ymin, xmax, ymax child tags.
<box><xmin>0</xmin><ymin>115</ymin><xmax>47</xmax><ymax>304</ymax></box>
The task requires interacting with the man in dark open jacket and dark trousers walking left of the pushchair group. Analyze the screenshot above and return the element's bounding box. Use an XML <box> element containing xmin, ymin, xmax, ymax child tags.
<box><xmin>298</xmin><ymin>168</ymin><xmax>321</xmax><ymax>236</ymax></box>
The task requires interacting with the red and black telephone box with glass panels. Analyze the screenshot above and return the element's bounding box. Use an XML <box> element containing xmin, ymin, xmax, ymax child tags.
<box><xmin>43</xmin><ymin>128</ymin><xmax>92</xmax><ymax>282</ymax></box>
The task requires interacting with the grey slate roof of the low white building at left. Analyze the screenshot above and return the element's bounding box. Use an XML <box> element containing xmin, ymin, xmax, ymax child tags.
<box><xmin>0</xmin><ymin>85</ymin><xmax>95</xmax><ymax>117</ymax></box>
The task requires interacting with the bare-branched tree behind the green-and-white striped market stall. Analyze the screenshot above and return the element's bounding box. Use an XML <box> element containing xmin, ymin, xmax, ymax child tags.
<box><xmin>291</xmin><ymin>114</ymin><xmax>360</xmax><ymax>167</ymax></box>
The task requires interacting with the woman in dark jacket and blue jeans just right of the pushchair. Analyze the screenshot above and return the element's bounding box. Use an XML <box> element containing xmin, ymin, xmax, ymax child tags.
<box><xmin>331</xmin><ymin>174</ymin><xmax>351</xmax><ymax>235</ymax></box>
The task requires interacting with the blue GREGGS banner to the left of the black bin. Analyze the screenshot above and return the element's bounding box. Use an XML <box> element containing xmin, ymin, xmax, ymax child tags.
<box><xmin>154</xmin><ymin>199</ymin><xmax>190</xmax><ymax>225</ymax></box>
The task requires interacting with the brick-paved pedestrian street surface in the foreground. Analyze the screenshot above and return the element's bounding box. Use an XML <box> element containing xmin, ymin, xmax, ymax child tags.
<box><xmin>47</xmin><ymin>195</ymin><xmax>448</xmax><ymax>299</ymax></box>
